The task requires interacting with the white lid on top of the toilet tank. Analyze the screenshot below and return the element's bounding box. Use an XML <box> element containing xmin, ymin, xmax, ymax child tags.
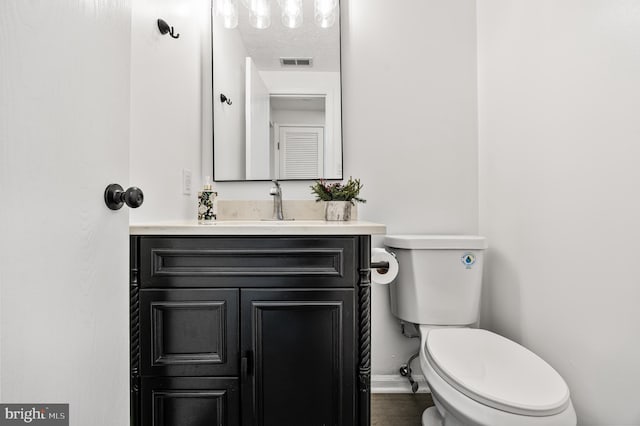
<box><xmin>384</xmin><ymin>234</ymin><xmax>488</xmax><ymax>250</ymax></box>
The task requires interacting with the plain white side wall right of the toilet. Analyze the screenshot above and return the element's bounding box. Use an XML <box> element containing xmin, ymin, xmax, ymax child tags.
<box><xmin>478</xmin><ymin>0</ymin><xmax>640</xmax><ymax>426</ymax></box>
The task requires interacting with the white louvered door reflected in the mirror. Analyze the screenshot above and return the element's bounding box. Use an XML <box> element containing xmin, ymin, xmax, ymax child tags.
<box><xmin>280</xmin><ymin>126</ymin><xmax>324</xmax><ymax>179</ymax></box>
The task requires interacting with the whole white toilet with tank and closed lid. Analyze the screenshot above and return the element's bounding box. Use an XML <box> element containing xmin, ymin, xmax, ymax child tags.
<box><xmin>385</xmin><ymin>235</ymin><xmax>576</xmax><ymax>426</ymax></box>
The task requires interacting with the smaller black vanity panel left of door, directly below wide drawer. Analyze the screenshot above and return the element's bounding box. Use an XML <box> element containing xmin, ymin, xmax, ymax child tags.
<box><xmin>140</xmin><ymin>289</ymin><xmax>239</xmax><ymax>376</ymax></box>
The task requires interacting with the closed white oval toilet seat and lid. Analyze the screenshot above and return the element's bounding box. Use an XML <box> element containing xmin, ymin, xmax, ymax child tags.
<box><xmin>424</xmin><ymin>328</ymin><xmax>570</xmax><ymax>416</ymax></box>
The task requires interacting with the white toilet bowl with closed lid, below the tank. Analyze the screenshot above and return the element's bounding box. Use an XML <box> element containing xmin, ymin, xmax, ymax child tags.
<box><xmin>420</xmin><ymin>326</ymin><xmax>576</xmax><ymax>426</ymax></box>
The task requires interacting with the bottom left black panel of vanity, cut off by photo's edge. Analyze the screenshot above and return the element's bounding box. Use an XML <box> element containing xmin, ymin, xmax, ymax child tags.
<box><xmin>141</xmin><ymin>377</ymin><xmax>240</xmax><ymax>426</ymax></box>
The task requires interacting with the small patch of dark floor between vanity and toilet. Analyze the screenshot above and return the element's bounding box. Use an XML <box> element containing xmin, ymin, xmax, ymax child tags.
<box><xmin>371</xmin><ymin>393</ymin><xmax>433</xmax><ymax>426</ymax></box>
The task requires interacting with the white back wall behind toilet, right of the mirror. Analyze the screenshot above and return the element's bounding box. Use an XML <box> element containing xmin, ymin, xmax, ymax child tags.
<box><xmin>342</xmin><ymin>0</ymin><xmax>478</xmax><ymax>374</ymax></box>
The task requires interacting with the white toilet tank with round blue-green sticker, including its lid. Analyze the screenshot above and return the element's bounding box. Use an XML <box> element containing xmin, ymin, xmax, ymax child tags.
<box><xmin>384</xmin><ymin>235</ymin><xmax>487</xmax><ymax>325</ymax></box>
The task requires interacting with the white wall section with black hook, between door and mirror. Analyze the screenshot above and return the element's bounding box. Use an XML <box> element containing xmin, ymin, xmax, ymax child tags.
<box><xmin>130</xmin><ymin>0</ymin><xmax>210</xmax><ymax>222</ymax></box>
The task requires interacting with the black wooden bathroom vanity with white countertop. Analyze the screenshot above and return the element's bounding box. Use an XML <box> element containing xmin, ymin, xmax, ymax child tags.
<box><xmin>131</xmin><ymin>221</ymin><xmax>385</xmax><ymax>426</ymax></box>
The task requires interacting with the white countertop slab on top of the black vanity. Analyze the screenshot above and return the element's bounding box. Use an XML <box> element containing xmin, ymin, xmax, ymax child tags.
<box><xmin>129</xmin><ymin>220</ymin><xmax>387</xmax><ymax>235</ymax></box>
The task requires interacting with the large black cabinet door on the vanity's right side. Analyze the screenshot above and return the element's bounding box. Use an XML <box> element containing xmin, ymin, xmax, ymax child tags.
<box><xmin>241</xmin><ymin>289</ymin><xmax>356</xmax><ymax>426</ymax></box>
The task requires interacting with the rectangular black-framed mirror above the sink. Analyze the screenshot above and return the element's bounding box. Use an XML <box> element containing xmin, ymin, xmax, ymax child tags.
<box><xmin>212</xmin><ymin>0</ymin><xmax>342</xmax><ymax>181</ymax></box>
